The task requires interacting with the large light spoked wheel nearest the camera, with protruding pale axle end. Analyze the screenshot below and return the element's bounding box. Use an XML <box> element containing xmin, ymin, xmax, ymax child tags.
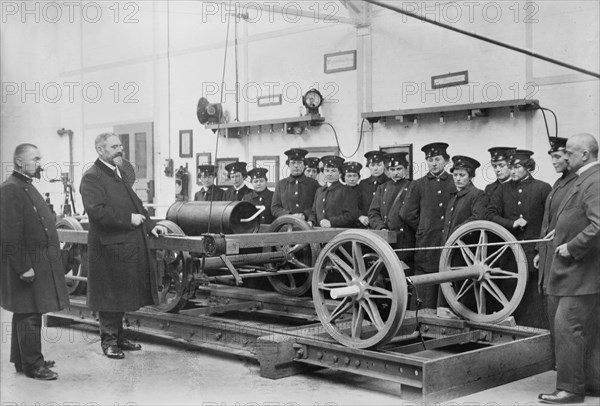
<box><xmin>312</xmin><ymin>230</ymin><xmax>408</xmax><ymax>348</ymax></box>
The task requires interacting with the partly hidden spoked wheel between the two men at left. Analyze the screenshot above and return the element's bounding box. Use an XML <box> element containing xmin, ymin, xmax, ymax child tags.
<box><xmin>56</xmin><ymin>217</ymin><xmax>88</xmax><ymax>295</ymax></box>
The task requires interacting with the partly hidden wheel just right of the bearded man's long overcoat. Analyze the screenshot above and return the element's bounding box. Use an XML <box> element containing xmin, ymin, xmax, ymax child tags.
<box><xmin>155</xmin><ymin>220</ymin><xmax>192</xmax><ymax>313</ymax></box>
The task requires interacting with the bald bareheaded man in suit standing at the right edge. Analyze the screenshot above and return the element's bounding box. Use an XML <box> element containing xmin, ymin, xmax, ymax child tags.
<box><xmin>539</xmin><ymin>134</ymin><xmax>600</xmax><ymax>404</ymax></box>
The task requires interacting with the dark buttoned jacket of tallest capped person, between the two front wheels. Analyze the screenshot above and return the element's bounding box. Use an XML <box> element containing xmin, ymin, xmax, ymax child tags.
<box><xmin>400</xmin><ymin>172</ymin><xmax>456</xmax><ymax>272</ymax></box>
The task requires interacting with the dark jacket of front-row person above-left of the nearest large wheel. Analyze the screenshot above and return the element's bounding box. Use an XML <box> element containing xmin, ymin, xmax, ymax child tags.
<box><xmin>309</xmin><ymin>182</ymin><xmax>358</xmax><ymax>227</ymax></box>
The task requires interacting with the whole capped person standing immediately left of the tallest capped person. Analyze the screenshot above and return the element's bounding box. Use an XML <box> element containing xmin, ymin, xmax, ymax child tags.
<box><xmin>369</xmin><ymin>152</ymin><xmax>415</xmax><ymax>275</ymax></box>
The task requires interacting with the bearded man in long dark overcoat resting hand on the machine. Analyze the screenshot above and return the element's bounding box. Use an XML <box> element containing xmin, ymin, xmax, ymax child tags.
<box><xmin>80</xmin><ymin>133</ymin><xmax>166</xmax><ymax>359</ymax></box>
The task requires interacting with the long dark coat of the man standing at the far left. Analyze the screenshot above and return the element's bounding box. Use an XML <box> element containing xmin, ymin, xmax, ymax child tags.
<box><xmin>0</xmin><ymin>172</ymin><xmax>69</xmax><ymax>312</ymax></box>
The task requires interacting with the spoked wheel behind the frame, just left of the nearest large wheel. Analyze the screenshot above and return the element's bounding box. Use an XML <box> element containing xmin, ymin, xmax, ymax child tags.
<box><xmin>265</xmin><ymin>216</ymin><xmax>320</xmax><ymax>296</ymax></box>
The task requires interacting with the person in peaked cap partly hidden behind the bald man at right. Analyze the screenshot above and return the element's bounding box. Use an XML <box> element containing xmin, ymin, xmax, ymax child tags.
<box><xmin>533</xmin><ymin>137</ymin><xmax>577</xmax><ymax>334</ymax></box>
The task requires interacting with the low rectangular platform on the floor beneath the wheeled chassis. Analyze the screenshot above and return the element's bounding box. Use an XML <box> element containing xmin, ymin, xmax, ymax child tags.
<box><xmin>47</xmin><ymin>285</ymin><xmax>553</xmax><ymax>402</ymax></box>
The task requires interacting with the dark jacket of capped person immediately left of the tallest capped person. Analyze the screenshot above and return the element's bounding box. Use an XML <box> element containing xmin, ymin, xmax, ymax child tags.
<box><xmin>369</xmin><ymin>179</ymin><xmax>415</xmax><ymax>259</ymax></box>
